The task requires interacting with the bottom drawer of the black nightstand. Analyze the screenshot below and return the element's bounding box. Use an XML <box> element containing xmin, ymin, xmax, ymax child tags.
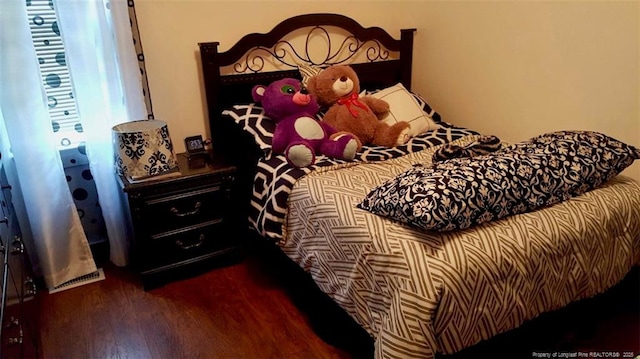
<box><xmin>142</xmin><ymin>219</ymin><xmax>232</xmax><ymax>270</ymax></box>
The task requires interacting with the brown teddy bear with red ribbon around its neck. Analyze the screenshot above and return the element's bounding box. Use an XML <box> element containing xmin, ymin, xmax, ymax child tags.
<box><xmin>307</xmin><ymin>65</ymin><xmax>409</xmax><ymax>147</ymax></box>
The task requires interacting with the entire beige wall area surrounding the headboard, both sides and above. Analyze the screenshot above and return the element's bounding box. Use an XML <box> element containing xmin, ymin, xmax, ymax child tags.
<box><xmin>136</xmin><ymin>0</ymin><xmax>640</xmax><ymax>180</ymax></box>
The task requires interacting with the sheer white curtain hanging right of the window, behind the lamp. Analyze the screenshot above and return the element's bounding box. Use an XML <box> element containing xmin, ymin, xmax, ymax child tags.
<box><xmin>55</xmin><ymin>0</ymin><xmax>147</xmax><ymax>266</ymax></box>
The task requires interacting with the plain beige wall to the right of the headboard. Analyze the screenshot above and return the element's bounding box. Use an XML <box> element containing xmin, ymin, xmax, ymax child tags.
<box><xmin>410</xmin><ymin>1</ymin><xmax>640</xmax><ymax>183</ymax></box>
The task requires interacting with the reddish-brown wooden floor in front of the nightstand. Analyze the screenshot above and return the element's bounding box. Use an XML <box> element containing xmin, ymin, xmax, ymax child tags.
<box><xmin>40</xmin><ymin>249</ymin><xmax>360</xmax><ymax>359</ymax></box>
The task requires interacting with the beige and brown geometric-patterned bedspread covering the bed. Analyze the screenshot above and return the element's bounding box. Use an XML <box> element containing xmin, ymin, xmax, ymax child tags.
<box><xmin>280</xmin><ymin>135</ymin><xmax>640</xmax><ymax>358</ymax></box>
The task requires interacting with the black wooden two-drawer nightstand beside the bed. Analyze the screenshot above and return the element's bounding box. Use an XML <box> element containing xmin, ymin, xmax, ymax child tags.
<box><xmin>120</xmin><ymin>152</ymin><xmax>240</xmax><ymax>290</ymax></box>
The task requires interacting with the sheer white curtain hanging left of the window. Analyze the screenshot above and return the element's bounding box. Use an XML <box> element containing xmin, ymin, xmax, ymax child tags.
<box><xmin>0</xmin><ymin>0</ymin><xmax>96</xmax><ymax>288</ymax></box>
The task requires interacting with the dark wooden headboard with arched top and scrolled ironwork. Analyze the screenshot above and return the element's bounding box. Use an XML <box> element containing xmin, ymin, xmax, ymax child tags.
<box><xmin>198</xmin><ymin>14</ymin><xmax>415</xmax><ymax>228</ymax></box>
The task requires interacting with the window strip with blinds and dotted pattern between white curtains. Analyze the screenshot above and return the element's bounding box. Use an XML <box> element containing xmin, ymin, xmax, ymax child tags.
<box><xmin>26</xmin><ymin>0</ymin><xmax>84</xmax><ymax>148</ymax></box>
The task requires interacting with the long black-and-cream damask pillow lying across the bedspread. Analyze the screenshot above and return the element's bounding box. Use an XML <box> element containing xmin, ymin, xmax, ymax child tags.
<box><xmin>357</xmin><ymin>131</ymin><xmax>640</xmax><ymax>231</ymax></box>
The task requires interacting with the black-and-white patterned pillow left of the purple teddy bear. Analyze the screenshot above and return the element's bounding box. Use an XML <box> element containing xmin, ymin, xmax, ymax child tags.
<box><xmin>222</xmin><ymin>104</ymin><xmax>276</xmax><ymax>153</ymax></box>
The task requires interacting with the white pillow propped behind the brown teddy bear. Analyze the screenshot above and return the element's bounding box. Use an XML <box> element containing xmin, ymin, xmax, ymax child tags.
<box><xmin>370</xmin><ymin>83</ymin><xmax>440</xmax><ymax>137</ymax></box>
